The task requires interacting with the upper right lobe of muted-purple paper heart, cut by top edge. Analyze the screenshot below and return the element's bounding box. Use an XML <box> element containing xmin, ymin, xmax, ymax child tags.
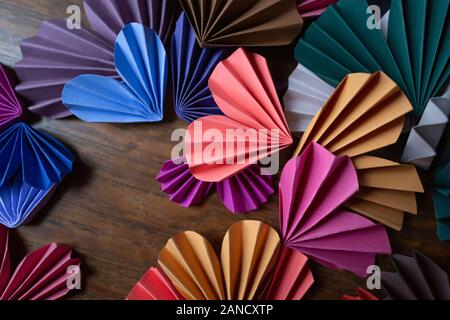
<box><xmin>84</xmin><ymin>0</ymin><xmax>179</xmax><ymax>45</ymax></box>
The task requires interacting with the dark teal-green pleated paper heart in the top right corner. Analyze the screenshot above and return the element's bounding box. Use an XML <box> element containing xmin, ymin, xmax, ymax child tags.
<box><xmin>295</xmin><ymin>0</ymin><xmax>450</xmax><ymax>116</ymax></box>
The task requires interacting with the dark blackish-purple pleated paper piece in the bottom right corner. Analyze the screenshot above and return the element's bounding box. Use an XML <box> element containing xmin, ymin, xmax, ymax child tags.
<box><xmin>381</xmin><ymin>252</ymin><xmax>450</xmax><ymax>300</ymax></box>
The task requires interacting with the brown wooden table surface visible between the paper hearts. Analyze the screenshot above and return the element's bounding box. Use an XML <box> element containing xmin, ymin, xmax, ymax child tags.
<box><xmin>0</xmin><ymin>0</ymin><xmax>450</xmax><ymax>299</ymax></box>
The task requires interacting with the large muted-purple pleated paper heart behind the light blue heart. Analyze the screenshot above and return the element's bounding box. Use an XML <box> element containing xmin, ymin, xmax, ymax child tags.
<box><xmin>14</xmin><ymin>0</ymin><xmax>179</xmax><ymax>118</ymax></box>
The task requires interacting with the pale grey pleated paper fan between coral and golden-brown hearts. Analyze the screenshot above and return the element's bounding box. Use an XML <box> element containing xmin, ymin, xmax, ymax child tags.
<box><xmin>284</xmin><ymin>64</ymin><xmax>334</xmax><ymax>132</ymax></box>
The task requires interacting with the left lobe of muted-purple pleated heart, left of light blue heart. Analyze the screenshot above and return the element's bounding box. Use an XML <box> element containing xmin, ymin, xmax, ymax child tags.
<box><xmin>14</xmin><ymin>20</ymin><xmax>117</xmax><ymax>118</ymax></box>
